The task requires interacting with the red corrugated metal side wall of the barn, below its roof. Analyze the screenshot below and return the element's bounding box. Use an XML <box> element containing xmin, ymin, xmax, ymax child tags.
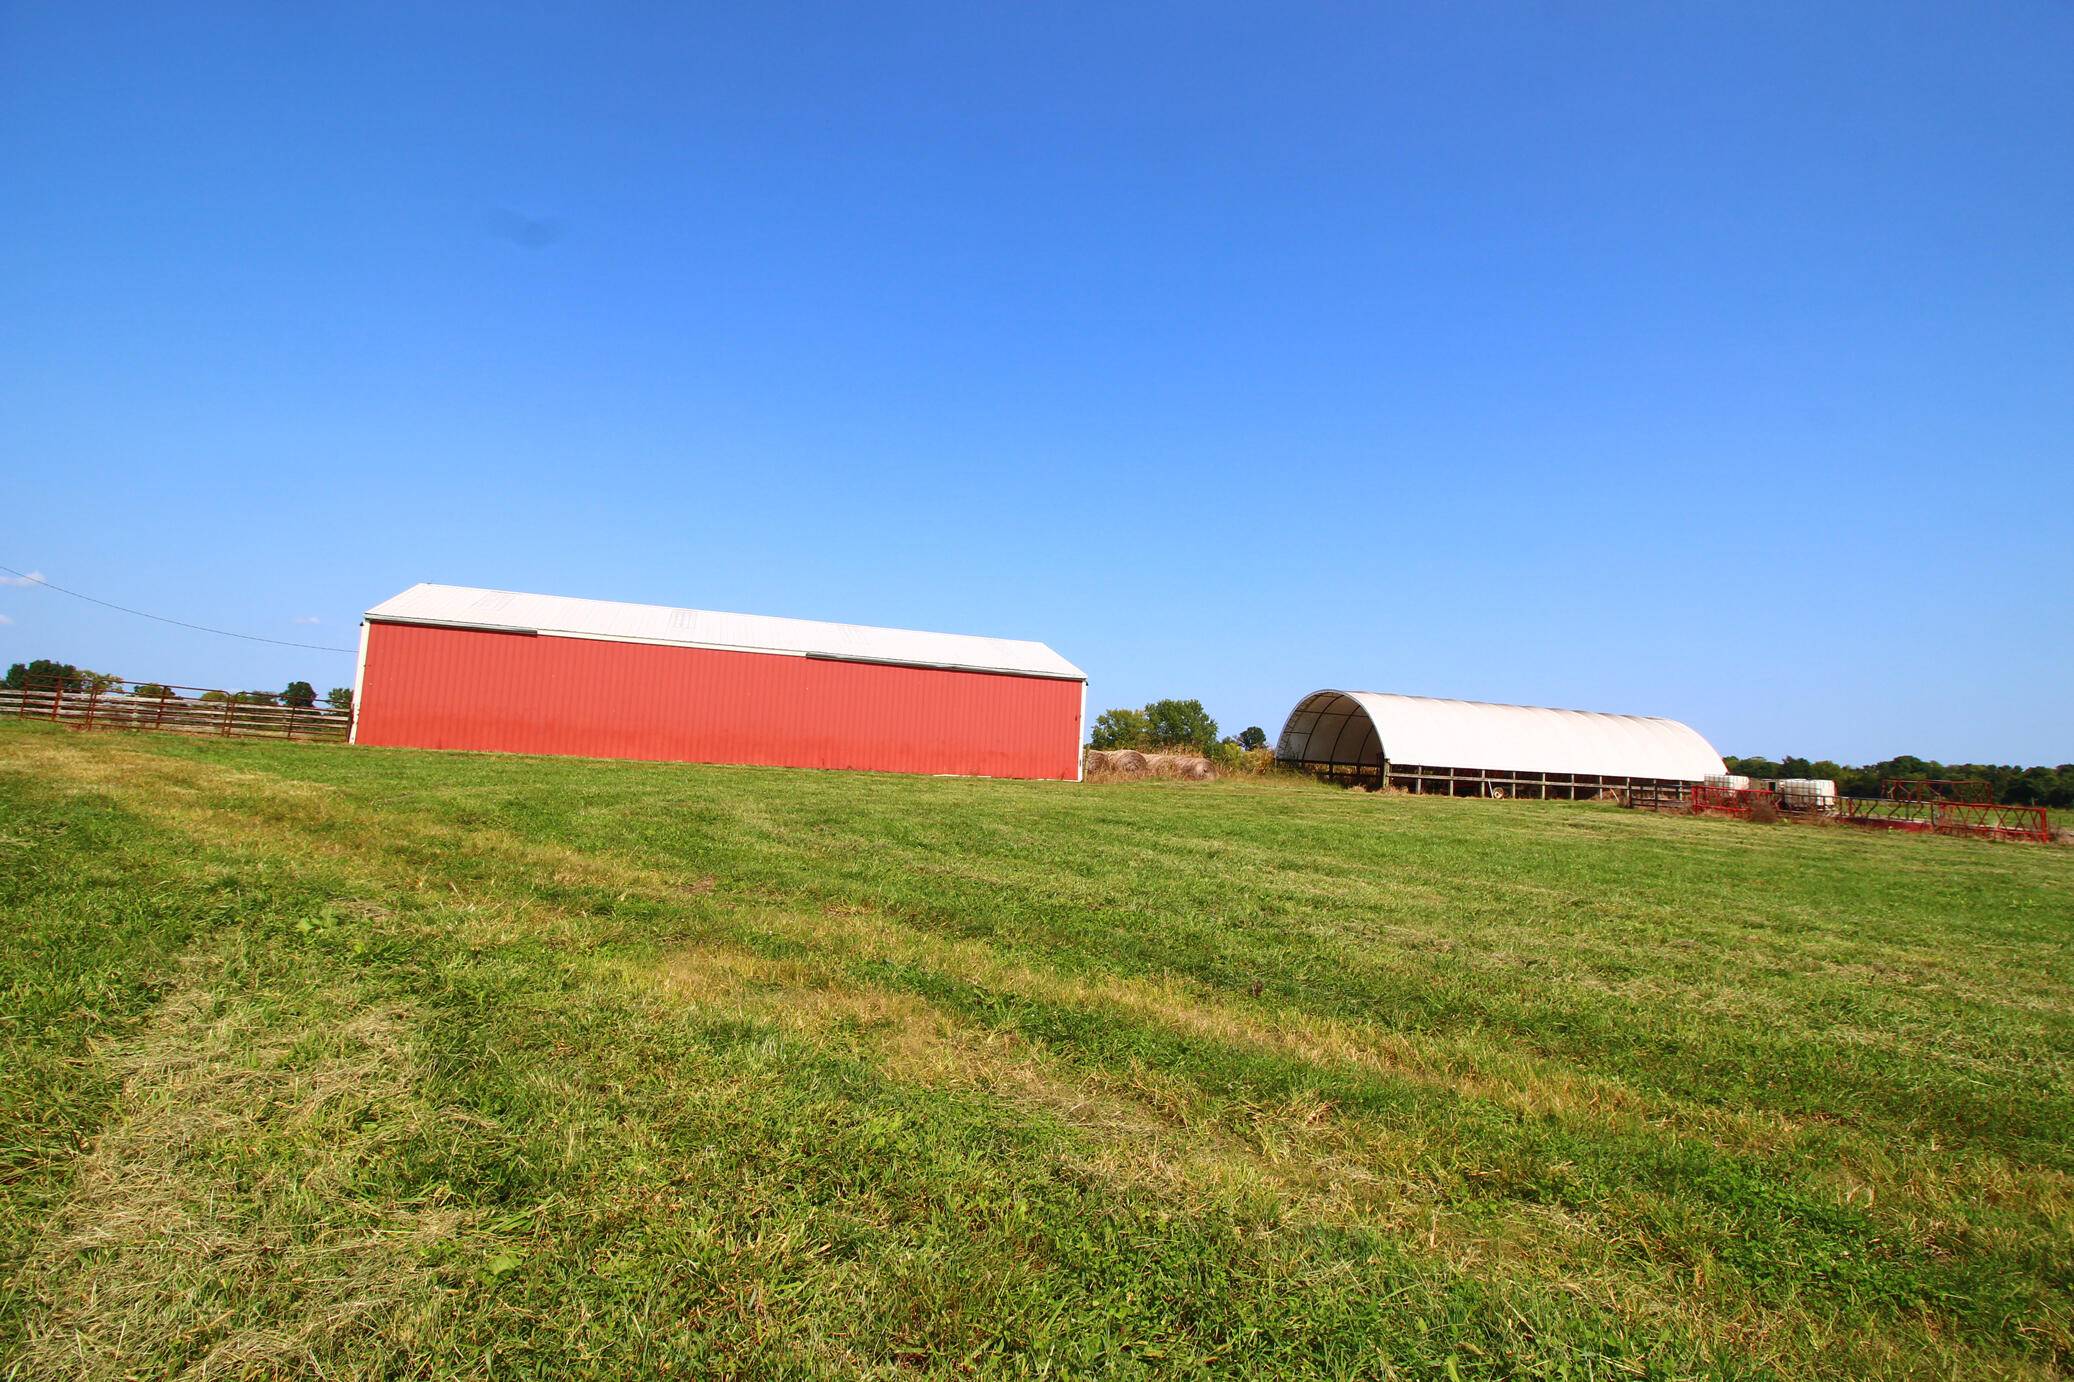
<box><xmin>357</xmin><ymin>623</ymin><xmax>1081</xmax><ymax>778</ymax></box>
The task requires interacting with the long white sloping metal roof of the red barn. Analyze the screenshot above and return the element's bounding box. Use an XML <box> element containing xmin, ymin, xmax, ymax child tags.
<box><xmin>367</xmin><ymin>585</ymin><xmax>1087</xmax><ymax>681</ymax></box>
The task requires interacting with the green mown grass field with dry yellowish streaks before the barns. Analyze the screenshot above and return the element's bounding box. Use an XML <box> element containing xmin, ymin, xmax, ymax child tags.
<box><xmin>0</xmin><ymin>724</ymin><xmax>2074</xmax><ymax>1378</ymax></box>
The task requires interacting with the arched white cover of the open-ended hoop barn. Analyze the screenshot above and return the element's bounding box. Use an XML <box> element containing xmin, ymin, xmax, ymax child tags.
<box><xmin>1276</xmin><ymin>691</ymin><xmax>1726</xmax><ymax>782</ymax></box>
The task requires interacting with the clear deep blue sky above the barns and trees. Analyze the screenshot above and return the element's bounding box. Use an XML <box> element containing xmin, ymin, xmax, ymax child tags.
<box><xmin>0</xmin><ymin>0</ymin><xmax>2074</xmax><ymax>762</ymax></box>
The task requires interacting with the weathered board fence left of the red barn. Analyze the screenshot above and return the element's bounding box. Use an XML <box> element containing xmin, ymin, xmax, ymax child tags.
<box><xmin>0</xmin><ymin>681</ymin><xmax>353</xmax><ymax>743</ymax></box>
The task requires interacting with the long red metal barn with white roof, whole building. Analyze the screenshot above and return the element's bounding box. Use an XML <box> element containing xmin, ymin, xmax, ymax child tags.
<box><xmin>353</xmin><ymin>585</ymin><xmax>1087</xmax><ymax>780</ymax></box>
